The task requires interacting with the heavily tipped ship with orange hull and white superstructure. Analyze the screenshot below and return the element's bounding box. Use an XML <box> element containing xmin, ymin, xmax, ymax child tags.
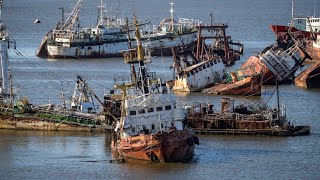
<box><xmin>240</xmin><ymin>41</ymin><xmax>311</xmax><ymax>84</ymax></box>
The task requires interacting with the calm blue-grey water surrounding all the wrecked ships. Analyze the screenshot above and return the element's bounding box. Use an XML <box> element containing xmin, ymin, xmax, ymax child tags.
<box><xmin>0</xmin><ymin>0</ymin><xmax>320</xmax><ymax>179</ymax></box>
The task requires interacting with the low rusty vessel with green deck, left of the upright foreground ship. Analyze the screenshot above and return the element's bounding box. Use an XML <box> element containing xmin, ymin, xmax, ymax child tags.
<box><xmin>0</xmin><ymin>73</ymin><xmax>111</xmax><ymax>132</ymax></box>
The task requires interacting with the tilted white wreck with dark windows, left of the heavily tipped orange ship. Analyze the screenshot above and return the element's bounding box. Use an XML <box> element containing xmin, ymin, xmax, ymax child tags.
<box><xmin>167</xmin><ymin>28</ymin><xmax>226</xmax><ymax>92</ymax></box>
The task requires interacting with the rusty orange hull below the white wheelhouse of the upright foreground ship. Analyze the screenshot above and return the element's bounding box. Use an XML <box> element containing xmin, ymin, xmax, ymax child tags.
<box><xmin>113</xmin><ymin>130</ymin><xmax>199</xmax><ymax>162</ymax></box>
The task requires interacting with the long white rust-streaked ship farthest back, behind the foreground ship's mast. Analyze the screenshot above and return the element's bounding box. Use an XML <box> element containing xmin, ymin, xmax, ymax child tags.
<box><xmin>37</xmin><ymin>0</ymin><xmax>200</xmax><ymax>58</ymax></box>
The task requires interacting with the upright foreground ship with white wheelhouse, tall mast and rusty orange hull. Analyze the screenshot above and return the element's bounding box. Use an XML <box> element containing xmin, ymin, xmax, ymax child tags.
<box><xmin>111</xmin><ymin>17</ymin><xmax>199</xmax><ymax>162</ymax></box>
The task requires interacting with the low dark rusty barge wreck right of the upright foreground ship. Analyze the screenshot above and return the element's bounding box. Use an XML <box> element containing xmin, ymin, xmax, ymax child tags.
<box><xmin>187</xmin><ymin>93</ymin><xmax>310</xmax><ymax>136</ymax></box>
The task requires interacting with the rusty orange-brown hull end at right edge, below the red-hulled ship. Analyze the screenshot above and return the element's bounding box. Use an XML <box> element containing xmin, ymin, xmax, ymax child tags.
<box><xmin>294</xmin><ymin>62</ymin><xmax>320</xmax><ymax>88</ymax></box>
